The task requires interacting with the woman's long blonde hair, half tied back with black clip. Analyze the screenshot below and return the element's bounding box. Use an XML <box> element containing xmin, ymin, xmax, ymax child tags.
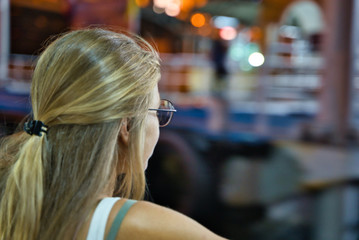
<box><xmin>0</xmin><ymin>28</ymin><xmax>160</xmax><ymax>240</ymax></box>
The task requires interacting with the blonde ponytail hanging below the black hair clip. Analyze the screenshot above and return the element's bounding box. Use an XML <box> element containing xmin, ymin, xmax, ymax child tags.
<box><xmin>0</xmin><ymin>133</ymin><xmax>46</xmax><ymax>240</ymax></box>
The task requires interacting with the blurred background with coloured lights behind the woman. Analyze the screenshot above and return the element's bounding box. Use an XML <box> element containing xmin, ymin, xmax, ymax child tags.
<box><xmin>0</xmin><ymin>0</ymin><xmax>359</xmax><ymax>240</ymax></box>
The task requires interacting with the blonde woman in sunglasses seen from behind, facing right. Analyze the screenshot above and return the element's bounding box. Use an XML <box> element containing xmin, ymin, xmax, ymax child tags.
<box><xmin>0</xmin><ymin>29</ymin><xmax>225</xmax><ymax>240</ymax></box>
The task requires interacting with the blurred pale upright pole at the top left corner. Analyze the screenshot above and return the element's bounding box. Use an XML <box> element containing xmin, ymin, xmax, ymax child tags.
<box><xmin>0</xmin><ymin>0</ymin><xmax>10</xmax><ymax>82</ymax></box>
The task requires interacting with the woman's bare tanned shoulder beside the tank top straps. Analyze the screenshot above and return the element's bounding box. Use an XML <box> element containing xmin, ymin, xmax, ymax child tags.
<box><xmin>109</xmin><ymin>199</ymin><xmax>228</xmax><ymax>240</ymax></box>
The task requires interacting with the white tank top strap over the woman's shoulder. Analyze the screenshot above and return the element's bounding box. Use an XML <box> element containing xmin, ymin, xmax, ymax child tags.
<box><xmin>86</xmin><ymin>197</ymin><xmax>120</xmax><ymax>240</ymax></box>
